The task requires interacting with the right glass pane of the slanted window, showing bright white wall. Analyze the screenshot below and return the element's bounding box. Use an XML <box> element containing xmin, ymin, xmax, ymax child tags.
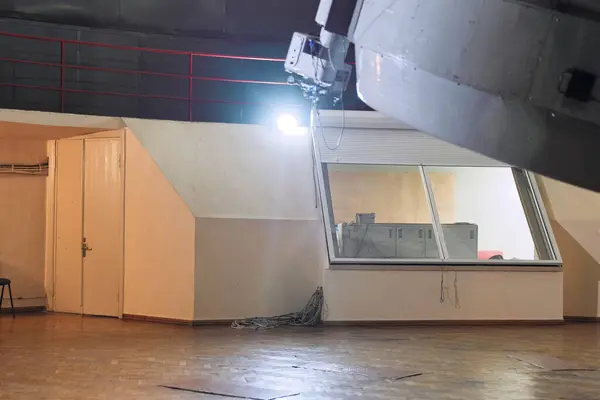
<box><xmin>425</xmin><ymin>167</ymin><xmax>552</xmax><ymax>260</ymax></box>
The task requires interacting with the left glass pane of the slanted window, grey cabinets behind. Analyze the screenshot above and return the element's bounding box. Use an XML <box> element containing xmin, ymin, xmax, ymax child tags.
<box><xmin>324</xmin><ymin>164</ymin><xmax>443</xmax><ymax>260</ymax></box>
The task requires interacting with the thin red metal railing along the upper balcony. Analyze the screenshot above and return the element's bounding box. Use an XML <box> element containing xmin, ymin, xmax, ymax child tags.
<box><xmin>0</xmin><ymin>31</ymin><xmax>299</xmax><ymax>121</ymax></box>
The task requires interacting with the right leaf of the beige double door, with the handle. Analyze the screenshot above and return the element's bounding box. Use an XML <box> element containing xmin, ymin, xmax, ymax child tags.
<box><xmin>82</xmin><ymin>139</ymin><xmax>123</xmax><ymax>317</ymax></box>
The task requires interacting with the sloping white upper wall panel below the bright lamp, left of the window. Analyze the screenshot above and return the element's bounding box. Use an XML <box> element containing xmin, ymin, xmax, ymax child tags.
<box><xmin>125</xmin><ymin>118</ymin><xmax>319</xmax><ymax>220</ymax></box>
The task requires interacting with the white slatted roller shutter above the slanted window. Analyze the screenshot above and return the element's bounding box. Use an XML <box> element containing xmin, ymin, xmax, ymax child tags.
<box><xmin>315</xmin><ymin>111</ymin><xmax>506</xmax><ymax>167</ymax></box>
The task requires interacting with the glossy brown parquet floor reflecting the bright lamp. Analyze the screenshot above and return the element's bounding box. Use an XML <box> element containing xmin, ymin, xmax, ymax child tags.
<box><xmin>0</xmin><ymin>314</ymin><xmax>600</xmax><ymax>400</ymax></box>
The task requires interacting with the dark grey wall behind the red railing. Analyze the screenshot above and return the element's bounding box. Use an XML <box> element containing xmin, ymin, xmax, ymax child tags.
<box><xmin>0</xmin><ymin>19</ymin><xmax>364</xmax><ymax>123</ymax></box>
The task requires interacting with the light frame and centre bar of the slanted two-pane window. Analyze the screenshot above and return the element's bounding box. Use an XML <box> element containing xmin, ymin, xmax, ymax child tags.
<box><xmin>315</xmin><ymin>161</ymin><xmax>562</xmax><ymax>269</ymax></box>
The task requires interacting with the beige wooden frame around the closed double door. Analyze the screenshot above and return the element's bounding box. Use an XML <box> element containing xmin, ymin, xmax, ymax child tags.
<box><xmin>45</xmin><ymin>129</ymin><xmax>126</xmax><ymax>319</ymax></box>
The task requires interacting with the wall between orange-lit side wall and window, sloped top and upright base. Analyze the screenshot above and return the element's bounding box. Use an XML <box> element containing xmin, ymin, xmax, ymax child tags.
<box><xmin>126</xmin><ymin>119</ymin><xmax>327</xmax><ymax>320</ymax></box>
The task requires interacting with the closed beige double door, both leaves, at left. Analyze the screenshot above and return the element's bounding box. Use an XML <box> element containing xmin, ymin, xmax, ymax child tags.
<box><xmin>54</xmin><ymin>139</ymin><xmax>123</xmax><ymax>317</ymax></box>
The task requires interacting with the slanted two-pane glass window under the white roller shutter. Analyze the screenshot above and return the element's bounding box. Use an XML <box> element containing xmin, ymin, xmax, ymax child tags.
<box><xmin>323</xmin><ymin>164</ymin><xmax>557</xmax><ymax>265</ymax></box>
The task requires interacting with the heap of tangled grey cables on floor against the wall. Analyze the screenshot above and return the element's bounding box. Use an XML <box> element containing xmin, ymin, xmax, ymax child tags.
<box><xmin>231</xmin><ymin>286</ymin><xmax>325</xmax><ymax>329</ymax></box>
